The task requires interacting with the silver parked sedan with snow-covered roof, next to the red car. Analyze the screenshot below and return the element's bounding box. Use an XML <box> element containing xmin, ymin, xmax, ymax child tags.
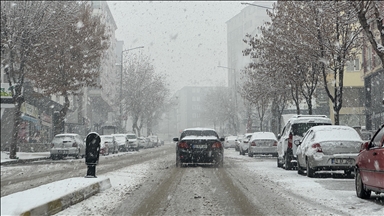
<box><xmin>294</xmin><ymin>125</ymin><xmax>363</xmax><ymax>177</ymax></box>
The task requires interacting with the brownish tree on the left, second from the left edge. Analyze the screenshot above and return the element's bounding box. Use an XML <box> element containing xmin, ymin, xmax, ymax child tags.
<box><xmin>28</xmin><ymin>2</ymin><xmax>109</xmax><ymax>134</ymax></box>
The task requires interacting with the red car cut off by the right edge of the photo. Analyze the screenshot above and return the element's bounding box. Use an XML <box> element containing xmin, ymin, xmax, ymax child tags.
<box><xmin>355</xmin><ymin>124</ymin><xmax>384</xmax><ymax>199</ymax></box>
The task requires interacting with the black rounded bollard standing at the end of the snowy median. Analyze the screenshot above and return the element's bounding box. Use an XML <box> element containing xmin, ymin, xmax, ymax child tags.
<box><xmin>85</xmin><ymin>132</ymin><xmax>101</xmax><ymax>178</ymax></box>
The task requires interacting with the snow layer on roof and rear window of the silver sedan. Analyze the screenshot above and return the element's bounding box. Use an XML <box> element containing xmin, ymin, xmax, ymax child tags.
<box><xmin>311</xmin><ymin>125</ymin><xmax>363</xmax><ymax>142</ymax></box>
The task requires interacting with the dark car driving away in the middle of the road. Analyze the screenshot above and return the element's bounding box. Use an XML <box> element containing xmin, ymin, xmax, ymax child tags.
<box><xmin>173</xmin><ymin>128</ymin><xmax>224</xmax><ymax>167</ymax></box>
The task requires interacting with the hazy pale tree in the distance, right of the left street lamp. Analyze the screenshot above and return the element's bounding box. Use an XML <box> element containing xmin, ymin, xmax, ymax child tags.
<box><xmin>123</xmin><ymin>53</ymin><xmax>169</xmax><ymax>136</ymax></box>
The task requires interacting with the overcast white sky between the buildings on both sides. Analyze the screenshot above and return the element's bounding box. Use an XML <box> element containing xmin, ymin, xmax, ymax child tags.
<box><xmin>108</xmin><ymin>1</ymin><xmax>260</xmax><ymax>93</ymax></box>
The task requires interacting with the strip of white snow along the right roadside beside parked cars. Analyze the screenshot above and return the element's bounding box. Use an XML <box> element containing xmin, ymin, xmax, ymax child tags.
<box><xmin>225</xmin><ymin>150</ymin><xmax>384</xmax><ymax>215</ymax></box>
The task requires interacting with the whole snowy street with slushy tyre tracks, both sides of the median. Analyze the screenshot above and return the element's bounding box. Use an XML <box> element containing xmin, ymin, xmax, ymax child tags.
<box><xmin>1</xmin><ymin>144</ymin><xmax>384</xmax><ymax>215</ymax></box>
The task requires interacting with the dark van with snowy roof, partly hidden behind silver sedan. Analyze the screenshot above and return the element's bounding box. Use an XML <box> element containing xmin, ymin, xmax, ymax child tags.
<box><xmin>277</xmin><ymin>115</ymin><xmax>332</xmax><ymax>170</ymax></box>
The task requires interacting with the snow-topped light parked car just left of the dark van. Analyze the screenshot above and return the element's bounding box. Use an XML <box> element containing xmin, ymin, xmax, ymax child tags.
<box><xmin>248</xmin><ymin>132</ymin><xmax>277</xmax><ymax>157</ymax></box>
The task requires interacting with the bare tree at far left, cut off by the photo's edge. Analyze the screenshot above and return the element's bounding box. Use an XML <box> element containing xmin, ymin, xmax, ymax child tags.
<box><xmin>1</xmin><ymin>1</ymin><xmax>80</xmax><ymax>159</ymax></box>
